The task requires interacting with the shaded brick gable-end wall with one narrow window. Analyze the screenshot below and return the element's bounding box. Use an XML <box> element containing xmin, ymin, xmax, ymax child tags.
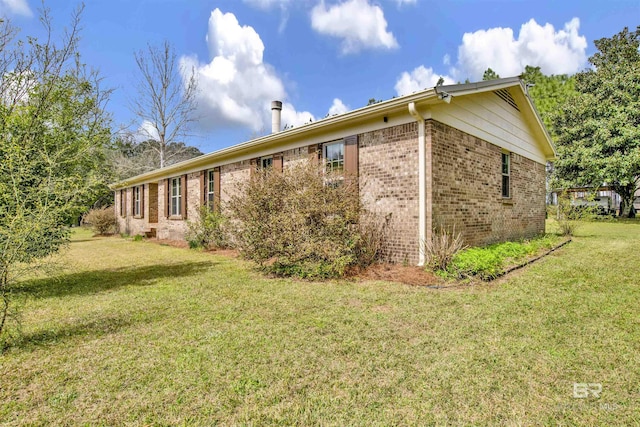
<box><xmin>426</xmin><ymin>120</ymin><xmax>545</xmax><ymax>245</ymax></box>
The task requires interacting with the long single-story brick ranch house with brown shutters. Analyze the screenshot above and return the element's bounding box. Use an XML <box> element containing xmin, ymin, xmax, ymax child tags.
<box><xmin>113</xmin><ymin>77</ymin><xmax>555</xmax><ymax>264</ymax></box>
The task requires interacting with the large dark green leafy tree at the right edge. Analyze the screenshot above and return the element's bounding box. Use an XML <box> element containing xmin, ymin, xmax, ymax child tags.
<box><xmin>553</xmin><ymin>27</ymin><xmax>640</xmax><ymax>216</ymax></box>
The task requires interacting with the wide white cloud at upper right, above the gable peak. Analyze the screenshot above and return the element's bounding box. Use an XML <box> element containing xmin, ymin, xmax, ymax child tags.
<box><xmin>456</xmin><ymin>18</ymin><xmax>587</xmax><ymax>80</ymax></box>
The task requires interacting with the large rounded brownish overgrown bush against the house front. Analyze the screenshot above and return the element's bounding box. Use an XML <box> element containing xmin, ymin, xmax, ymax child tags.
<box><xmin>227</xmin><ymin>162</ymin><xmax>384</xmax><ymax>277</ymax></box>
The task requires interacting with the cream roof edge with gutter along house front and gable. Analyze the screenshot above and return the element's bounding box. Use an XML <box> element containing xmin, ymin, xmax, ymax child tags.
<box><xmin>110</xmin><ymin>77</ymin><xmax>555</xmax><ymax>190</ymax></box>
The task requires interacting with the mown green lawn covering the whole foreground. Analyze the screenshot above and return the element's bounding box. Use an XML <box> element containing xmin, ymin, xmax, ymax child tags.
<box><xmin>0</xmin><ymin>221</ymin><xmax>640</xmax><ymax>426</ymax></box>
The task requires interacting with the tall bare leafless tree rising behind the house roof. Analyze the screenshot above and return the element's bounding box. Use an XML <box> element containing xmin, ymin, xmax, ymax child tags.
<box><xmin>131</xmin><ymin>42</ymin><xmax>197</xmax><ymax>169</ymax></box>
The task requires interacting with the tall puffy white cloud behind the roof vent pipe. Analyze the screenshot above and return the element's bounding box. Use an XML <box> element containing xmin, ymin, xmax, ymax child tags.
<box><xmin>180</xmin><ymin>9</ymin><xmax>313</xmax><ymax>132</ymax></box>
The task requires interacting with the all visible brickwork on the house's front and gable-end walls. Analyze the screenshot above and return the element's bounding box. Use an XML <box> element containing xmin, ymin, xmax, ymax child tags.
<box><xmin>115</xmin><ymin>120</ymin><xmax>545</xmax><ymax>264</ymax></box>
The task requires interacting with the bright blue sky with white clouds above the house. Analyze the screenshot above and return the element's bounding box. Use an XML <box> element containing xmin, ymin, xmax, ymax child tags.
<box><xmin>0</xmin><ymin>0</ymin><xmax>640</xmax><ymax>152</ymax></box>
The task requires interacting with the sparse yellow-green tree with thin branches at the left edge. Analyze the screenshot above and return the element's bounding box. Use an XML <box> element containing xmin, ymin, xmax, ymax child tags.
<box><xmin>0</xmin><ymin>8</ymin><xmax>110</xmax><ymax>342</ymax></box>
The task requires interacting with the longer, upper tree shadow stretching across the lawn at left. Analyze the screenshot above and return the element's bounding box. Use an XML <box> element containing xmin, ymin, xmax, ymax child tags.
<box><xmin>14</xmin><ymin>261</ymin><xmax>217</xmax><ymax>298</ymax></box>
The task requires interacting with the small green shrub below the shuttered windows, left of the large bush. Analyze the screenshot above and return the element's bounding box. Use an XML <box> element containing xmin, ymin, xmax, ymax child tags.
<box><xmin>185</xmin><ymin>206</ymin><xmax>228</xmax><ymax>249</ymax></box>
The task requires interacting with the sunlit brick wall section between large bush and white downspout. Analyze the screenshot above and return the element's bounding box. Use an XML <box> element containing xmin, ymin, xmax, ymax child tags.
<box><xmin>358</xmin><ymin>122</ymin><xmax>419</xmax><ymax>264</ymax></box>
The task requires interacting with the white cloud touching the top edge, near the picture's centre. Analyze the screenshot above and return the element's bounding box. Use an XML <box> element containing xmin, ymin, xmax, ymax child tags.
<box><xmin>311</xmin><ymin>0</ymin><xmax>398</xmax><ymax>54</ymax></box>
